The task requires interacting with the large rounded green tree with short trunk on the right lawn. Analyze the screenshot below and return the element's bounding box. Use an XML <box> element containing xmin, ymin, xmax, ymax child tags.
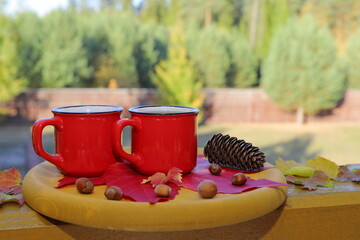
<box><xmin>262</xmin><ymin>16</ymin><xmax>345</xmax><ymax>123</ymax></box>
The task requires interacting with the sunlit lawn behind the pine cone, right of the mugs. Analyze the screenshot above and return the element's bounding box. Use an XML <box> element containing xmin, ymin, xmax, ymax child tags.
<box><xmin>199</xmin><ymin>123</ymin><xmax>360</xmax><ymax>165</ymax></box>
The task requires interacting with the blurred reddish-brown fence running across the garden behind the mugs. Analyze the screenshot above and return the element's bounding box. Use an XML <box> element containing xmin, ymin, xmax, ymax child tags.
<box><xmin>4</xmin><ymin>88</ymin><xmax>360</xmax><ymax>124</ymax></box>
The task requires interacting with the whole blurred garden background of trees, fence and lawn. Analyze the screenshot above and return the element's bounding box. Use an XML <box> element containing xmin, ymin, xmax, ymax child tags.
<box><xmin>0</xmin><ymin>0</ymin><xmax>360</xmax><ymax>174</ymax></box>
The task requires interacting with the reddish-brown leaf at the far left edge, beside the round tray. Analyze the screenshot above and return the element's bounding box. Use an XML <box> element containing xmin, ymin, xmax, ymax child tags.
<box><xmin>0</xmin><ymin>168</ymin><xmax>22</xmax><ymax>195</ymax></box>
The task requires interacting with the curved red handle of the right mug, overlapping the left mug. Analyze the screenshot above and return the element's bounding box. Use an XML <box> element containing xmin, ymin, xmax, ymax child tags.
<box><xmin>113</xmin><ymin>118</ymin><xmax>141</xmax><ymax>163</ymax></box>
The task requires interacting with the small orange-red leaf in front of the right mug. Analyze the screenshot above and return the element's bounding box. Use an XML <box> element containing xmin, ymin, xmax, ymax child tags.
<box><xmin>141</xmin><ymin>167</ymin><xmax>182</xmax><ymax>187</ymax></box>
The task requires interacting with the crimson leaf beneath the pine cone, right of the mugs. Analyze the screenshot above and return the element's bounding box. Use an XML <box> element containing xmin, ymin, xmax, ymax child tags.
<box><xmin>182</xmin><ymin>158</ymin><xmax>289</xmax><ymax>193</ymax></box>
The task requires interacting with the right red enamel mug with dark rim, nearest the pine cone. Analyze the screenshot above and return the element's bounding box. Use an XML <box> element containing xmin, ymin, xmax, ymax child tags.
<box><xmin>113</xmin><ymin>105</ymin><xmax>199</xmax><ymax>175</ymax></box>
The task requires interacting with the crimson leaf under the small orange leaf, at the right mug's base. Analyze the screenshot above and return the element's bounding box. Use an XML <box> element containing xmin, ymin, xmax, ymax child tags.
<box><xmin>104</xmin><ymin>162</ymin><xmax>180</xmax><ymax>204</ymax></box>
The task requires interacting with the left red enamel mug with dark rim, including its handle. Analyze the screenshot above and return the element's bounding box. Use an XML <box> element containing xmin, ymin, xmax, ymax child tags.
<box><xmin>32</xmin><ymin>105</ymin><xmax>123</xmax><ymax>177</ymax></box>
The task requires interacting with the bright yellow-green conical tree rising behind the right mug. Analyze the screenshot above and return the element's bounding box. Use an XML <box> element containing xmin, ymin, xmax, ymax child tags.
<box><xmin>152</xmin><ymin>23</ymin><xmax>204</xmax><ymax>108</ymax></box>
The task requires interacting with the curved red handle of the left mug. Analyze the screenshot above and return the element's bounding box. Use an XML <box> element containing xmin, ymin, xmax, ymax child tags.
<box><xmin>32</xmin><ymin>118</ymin><xmax>64</xmax><ymax>169</ymax></box>
